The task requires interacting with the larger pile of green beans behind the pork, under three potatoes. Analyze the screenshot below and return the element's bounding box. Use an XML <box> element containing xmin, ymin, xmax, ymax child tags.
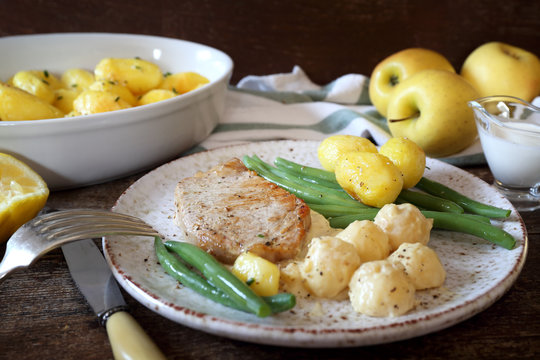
<box><xmin>242</xmin><ymin>155</ymin><xmax>516</xmax><ymax>249</ymax></box>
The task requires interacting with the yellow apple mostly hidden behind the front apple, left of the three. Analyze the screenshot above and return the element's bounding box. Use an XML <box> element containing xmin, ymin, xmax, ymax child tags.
<box><xmin>369</xmin><ymin>48</ymin><xmax>455</xmax><ymax>116</ymax></box>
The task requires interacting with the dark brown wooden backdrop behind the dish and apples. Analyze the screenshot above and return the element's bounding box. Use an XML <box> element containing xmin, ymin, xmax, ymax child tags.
<box><xmin>0</xmin><ymin>0</ymin><xmax>540</xmax><ymax>84</ymax></box>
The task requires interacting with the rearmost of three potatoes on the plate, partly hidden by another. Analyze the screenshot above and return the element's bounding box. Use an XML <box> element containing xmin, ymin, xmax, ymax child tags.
<box><xmin>317</xmin><ymin>135</ymin><xmax>377</xmax><ymax>171</ymax></box>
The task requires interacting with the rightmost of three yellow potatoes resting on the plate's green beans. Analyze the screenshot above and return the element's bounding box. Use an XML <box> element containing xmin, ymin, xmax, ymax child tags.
<box><xmin>379</xmin><ymin>137</ymin><xmax>426</xmax><ymax>189</ymax></box>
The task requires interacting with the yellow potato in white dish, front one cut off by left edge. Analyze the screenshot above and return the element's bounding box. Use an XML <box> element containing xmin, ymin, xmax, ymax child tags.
<box><xmin>0</xmin><ymin>83</ymin><xmax>64</xmax><ymax>121</ymax></box>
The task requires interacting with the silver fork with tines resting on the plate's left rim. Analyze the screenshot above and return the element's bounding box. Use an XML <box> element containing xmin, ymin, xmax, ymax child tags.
<box><xmin>0</xmin><ymin>209</ymin><xmax>159</xmax><ymax>283</ymax></box>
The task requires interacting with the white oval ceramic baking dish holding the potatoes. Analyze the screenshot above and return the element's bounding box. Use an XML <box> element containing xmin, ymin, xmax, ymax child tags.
<box><xmin>0</xmin><ymin>33</ymin><xmax>233</xmax><ymax>190</ymax></box>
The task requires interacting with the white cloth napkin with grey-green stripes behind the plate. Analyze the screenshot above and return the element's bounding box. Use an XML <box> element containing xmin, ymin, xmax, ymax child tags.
<box><xmin>196</xmin><ymin>66</ymin><xmax>485</xmax><ymax>166</ymax></box>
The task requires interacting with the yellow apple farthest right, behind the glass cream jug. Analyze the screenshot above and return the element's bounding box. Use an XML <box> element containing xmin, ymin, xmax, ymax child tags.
<box><xmin>461</xmin><ymin>41</ymin><xmax>540</xmax><ymax>101</ymax></box>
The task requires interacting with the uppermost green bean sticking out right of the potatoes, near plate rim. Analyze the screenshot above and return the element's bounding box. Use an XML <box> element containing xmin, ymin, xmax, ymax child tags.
<box><xmin>416</xmin><ymin>177</ymin><xmax>511</xmax><ymax>218</ymax></box>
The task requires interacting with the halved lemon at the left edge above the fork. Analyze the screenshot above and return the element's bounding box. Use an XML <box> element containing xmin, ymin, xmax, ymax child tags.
<box><xmin>0</xmin><ymin>153</ymin><xmax>49</xmax><ymax>242</ymax></box>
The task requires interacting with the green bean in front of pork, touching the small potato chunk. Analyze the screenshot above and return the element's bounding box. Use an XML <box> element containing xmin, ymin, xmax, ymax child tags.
<box><xmin>165</xmin><ymin>241</ymin><xmax>272</xmax><ymax>317</ymax></box>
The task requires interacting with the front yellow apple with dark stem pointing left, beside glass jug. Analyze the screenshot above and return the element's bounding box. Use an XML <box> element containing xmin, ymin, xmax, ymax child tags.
<box><xmin>388</xmin><ymin>70</ymin><xmax>478</xmax><ymax>157</ymax></box>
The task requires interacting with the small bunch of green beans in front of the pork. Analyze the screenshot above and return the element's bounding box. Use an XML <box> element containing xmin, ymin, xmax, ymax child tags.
<box><xmin>154</xmin><ymin>237</ymin><xmax>296</xmax><ymax>317</ymax></box>
